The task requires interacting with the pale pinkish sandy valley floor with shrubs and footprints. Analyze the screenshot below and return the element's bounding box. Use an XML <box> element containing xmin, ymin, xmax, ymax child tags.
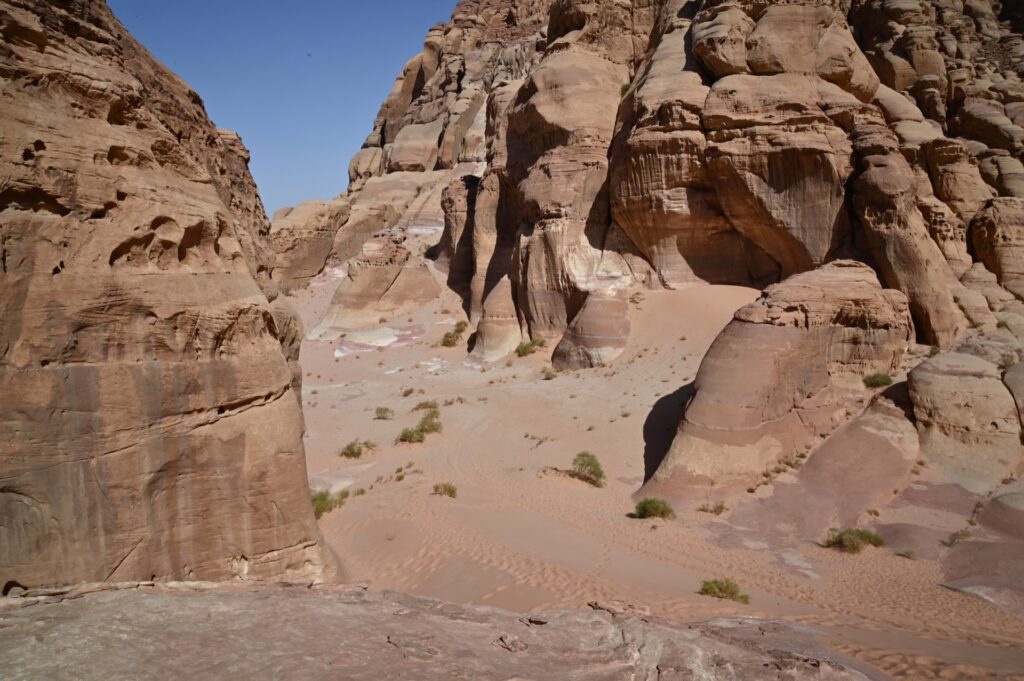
<box><xmin>292</xmin><ymin>275</ymin><xmax>1024</xmax><ymax>679</ymax></box>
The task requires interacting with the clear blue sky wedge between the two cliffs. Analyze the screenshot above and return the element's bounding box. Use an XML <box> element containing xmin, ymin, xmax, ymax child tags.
<box><xmin>109</xmin><ymin>0</ymin><xmax>456</xmax><ymax>215</ymax></box>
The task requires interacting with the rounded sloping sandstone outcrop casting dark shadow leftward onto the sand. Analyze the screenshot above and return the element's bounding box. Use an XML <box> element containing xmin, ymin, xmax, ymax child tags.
<box><xmin>645</xmin><ymin>260</ymin><xmax>912</xmax><ymax>497</ymax></box>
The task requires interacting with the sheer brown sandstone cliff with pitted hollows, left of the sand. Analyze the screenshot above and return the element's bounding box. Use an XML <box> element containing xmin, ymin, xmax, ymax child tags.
<box><xmin>0</xmin><ymin>0</ymin><xmax>324</xmax><ymax>586</ymax></box>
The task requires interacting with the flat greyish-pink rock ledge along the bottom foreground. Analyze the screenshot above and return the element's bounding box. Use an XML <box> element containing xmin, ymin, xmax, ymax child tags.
<box><xmin>0</xmin><ymin>585</ymin><xmax>882</xmax><ymax>681</ymax></box>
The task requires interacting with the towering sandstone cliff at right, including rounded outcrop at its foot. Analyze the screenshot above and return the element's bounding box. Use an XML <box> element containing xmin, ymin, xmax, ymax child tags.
<box><xmin>282</xmin><ymin>0</ymin><xmax>1024</xmax><ymax>496</ymax></box>
